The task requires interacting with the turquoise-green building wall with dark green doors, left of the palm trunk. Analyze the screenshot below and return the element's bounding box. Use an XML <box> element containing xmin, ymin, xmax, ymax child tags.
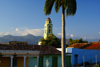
<box><xmin>28</xmin><ymin>55</ymin><xmax>62</xmax><ymax>67</ymax></box>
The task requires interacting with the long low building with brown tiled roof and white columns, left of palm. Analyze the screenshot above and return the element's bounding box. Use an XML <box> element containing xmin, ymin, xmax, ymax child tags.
<box><xmin>0</xmin><ymin>44</ymin><xmax>61</xmax><ymax>67</ymax></box>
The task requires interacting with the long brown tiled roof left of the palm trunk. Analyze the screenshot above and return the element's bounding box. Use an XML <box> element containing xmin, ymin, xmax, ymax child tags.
<box><xmin>0</xmin><ymin>44</ymin><xmax>61</xmax><ymax>55</ymax></box>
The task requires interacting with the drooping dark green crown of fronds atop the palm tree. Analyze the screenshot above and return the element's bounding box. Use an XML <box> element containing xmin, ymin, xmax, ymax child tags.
<box><xmin>44</xmin><ymin>0</ymin><xmax>77</xmax><ymax>16</ymax></box>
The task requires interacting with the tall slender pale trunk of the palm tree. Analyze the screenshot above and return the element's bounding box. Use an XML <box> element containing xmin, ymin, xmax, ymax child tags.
<box><xmin>61</xmin><ymin>5</ymin><xmax>66</xmax><ymax>67</ymax></box>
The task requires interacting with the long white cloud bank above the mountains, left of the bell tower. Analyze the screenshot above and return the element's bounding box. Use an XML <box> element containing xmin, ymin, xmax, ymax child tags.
<box><xmin>0</xmin><ymin>27</ymin><xmax>44</xmax><ymax>36</ymax></box>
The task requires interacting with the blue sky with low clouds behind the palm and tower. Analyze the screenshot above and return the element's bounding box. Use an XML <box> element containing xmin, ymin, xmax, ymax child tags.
<box><xmin>0</xmin><ymin>0</ymin><xmax>100</xmax><ymax>40</ymax></box>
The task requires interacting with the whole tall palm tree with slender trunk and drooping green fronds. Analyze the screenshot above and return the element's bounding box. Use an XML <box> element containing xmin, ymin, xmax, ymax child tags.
<box><xmin>44</xmin><ymin>0</ymin><xmax>76</xmax><ymax>67</ymax></box>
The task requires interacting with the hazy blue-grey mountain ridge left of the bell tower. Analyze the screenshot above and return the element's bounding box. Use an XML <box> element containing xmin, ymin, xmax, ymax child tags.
<box><xmin>0</xmin><ymin>34</ymin><xmax>43</xmax><ymax>45</ymax></box>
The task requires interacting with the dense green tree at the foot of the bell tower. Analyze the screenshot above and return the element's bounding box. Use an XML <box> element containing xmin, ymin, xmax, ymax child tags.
<box><xmin>40</xmin><ymin>34</ymin><xmax>61</xmax><ymax>47</ymax></box>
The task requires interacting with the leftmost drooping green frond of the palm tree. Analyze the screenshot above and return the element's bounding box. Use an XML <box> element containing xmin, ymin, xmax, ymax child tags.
<box><xmin>44</xmin><ymin>0</ymin><xmax>55</xmax><ymax>15</ymax></box>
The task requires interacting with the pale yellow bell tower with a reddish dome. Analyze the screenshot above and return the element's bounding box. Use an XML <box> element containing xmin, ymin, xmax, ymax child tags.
<box><xmin>44</xmin><ymin>17</ymin><xmax>52</xmax><ymax>39</ymax></box>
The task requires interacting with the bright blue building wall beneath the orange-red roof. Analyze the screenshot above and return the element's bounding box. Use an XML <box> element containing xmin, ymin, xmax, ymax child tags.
<box><xmin>66</xmin><ymin>48</ymin><xmax>100</xmax><ymax>66</ymax></box>
